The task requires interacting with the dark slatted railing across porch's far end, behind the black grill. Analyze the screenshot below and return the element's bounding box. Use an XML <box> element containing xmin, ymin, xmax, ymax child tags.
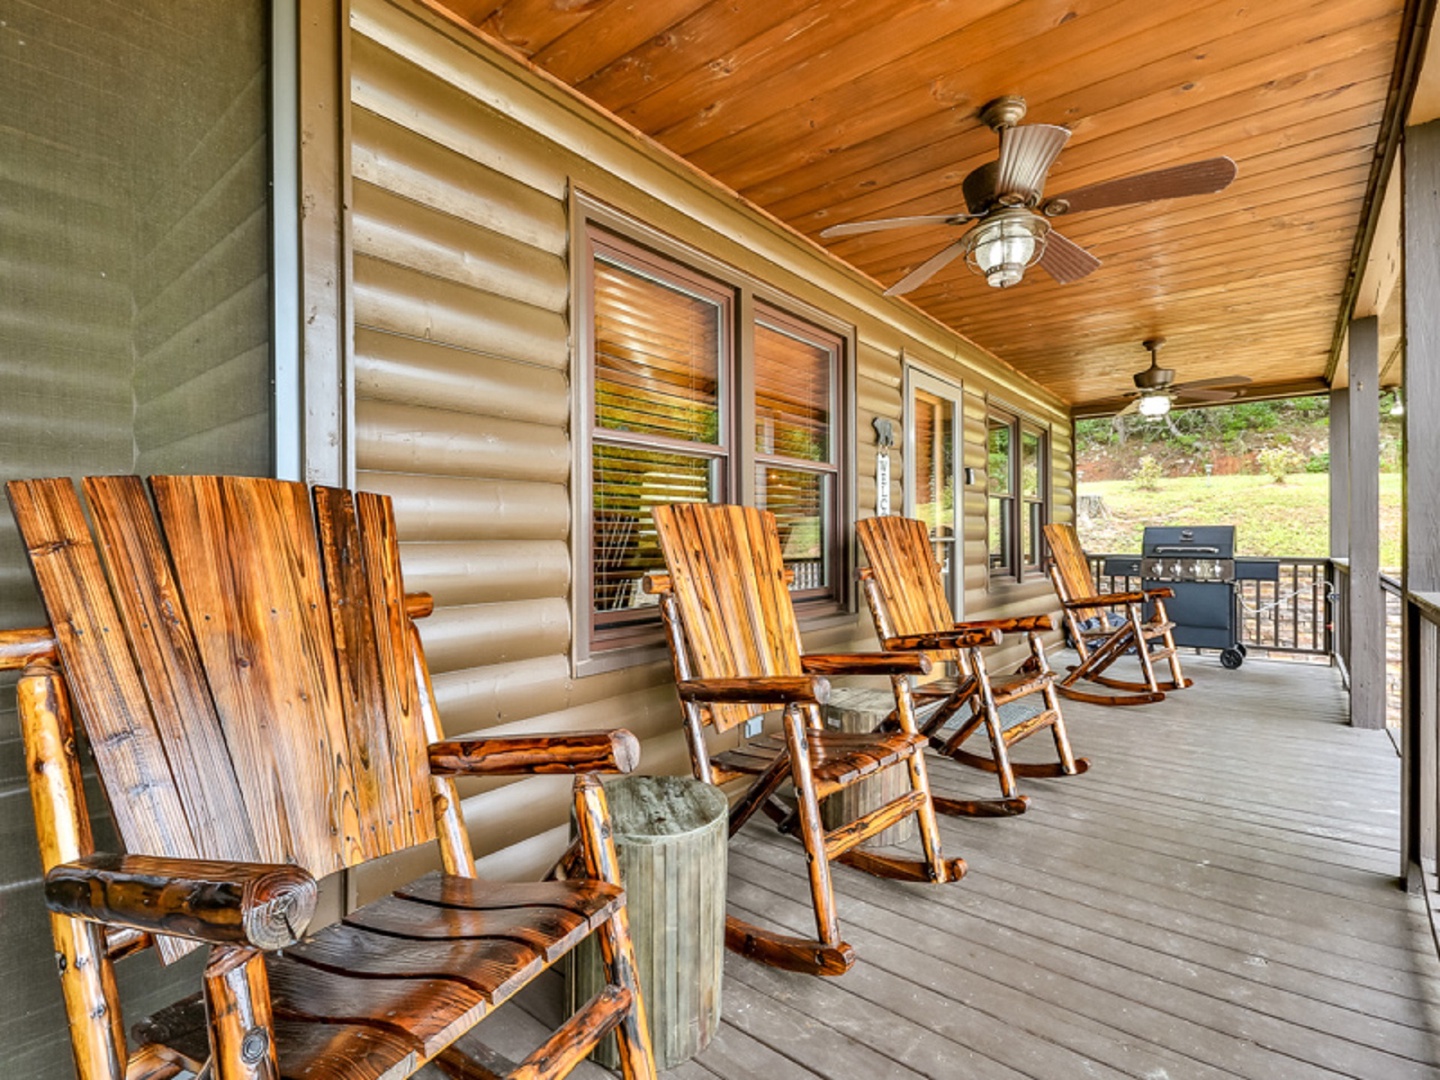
<box><xmin>1090</xmin><ymin>554</ymin><xmax>1336</xmax><ymax>657</ymax></box>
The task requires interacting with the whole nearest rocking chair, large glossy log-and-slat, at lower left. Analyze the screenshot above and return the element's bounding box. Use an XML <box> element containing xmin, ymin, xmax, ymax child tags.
<box><xmin>0</xmin><ymin>477</ymin><xmax>655</xmax><ymax>1080</ymax></box>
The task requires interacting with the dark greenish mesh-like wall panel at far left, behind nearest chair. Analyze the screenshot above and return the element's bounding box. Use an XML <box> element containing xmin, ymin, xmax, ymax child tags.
<box><xmin>0</xmin><ymin>0</ymin><xmax>272</xmax><ymax>1080</ymax></box>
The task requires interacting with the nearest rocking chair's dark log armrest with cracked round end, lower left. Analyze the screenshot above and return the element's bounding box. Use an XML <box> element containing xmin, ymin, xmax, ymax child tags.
<box><xmin>45</xmin><ymin>854</ymin><xmax>317</xmax><ymax>950</ymax></box>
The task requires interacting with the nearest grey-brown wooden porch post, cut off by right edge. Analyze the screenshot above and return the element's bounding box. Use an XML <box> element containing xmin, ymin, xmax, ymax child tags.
<box><xmin>1400</xmin><ymin>114</ymin><xmax>1440</xmax><ymax>888</ymax></box>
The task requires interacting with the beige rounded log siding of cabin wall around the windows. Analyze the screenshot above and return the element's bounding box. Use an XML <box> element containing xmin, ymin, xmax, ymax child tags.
<box><xmin>350</xmin><ymin>0</ymin><xmax>1068</xmax><ymax>899</ymax></box>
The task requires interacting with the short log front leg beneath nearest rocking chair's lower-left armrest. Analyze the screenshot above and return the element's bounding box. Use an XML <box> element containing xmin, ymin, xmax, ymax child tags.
<box><xmin>204</xmin><ymin>946</ymin><xmax>279</xmax><ymax>1080</ymax></box>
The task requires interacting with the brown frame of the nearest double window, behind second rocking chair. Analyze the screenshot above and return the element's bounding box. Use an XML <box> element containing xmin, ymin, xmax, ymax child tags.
<box><xmin>570</xmin><ymin>192</ymin><xmax>855</xmax><ymax>677</ymax></box>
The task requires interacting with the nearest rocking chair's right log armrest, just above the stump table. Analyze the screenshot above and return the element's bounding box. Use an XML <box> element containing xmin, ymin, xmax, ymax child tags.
<box><xmin>429</xmin><ymin>727</ymin><xmax>639</xmax><ymax>776</ymax></box>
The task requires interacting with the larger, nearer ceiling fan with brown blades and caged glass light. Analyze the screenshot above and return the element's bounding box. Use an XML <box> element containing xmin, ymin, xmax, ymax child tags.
<box><xmin>819</xmin><ymin>95</ymin><xmax>1236</xmax><ymax>297</ymax></box>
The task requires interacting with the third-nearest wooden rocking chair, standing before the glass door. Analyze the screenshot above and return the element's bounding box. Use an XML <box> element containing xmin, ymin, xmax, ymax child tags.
<box><xmin>855</xmin><ymin>516</ymin><xmax>1090</xmax><ymax>816</ymax></box>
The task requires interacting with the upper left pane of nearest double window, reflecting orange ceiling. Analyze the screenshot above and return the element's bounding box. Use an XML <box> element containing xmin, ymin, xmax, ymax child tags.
<box><xmin>595</xmin><ymin>256</ymin><xmax>724</xmax><ymax>446</ymax></box>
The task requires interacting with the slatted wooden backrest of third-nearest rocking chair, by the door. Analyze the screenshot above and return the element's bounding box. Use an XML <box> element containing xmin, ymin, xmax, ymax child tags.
<box><xmin>855</xmin><ymin>514</ymin><xmax>956</xmax><ymax>660</ymax></box>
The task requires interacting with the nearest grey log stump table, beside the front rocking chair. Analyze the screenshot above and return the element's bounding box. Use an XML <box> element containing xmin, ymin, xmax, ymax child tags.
<box><xmin>569</xmin><ymin>776</ymin><xmax>730</xmax><ymax>1070</ymax></box>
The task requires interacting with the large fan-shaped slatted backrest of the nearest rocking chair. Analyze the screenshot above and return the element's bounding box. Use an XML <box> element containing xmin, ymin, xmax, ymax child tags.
<box><xmin>9</xmin><ymin>477</ymin><xmax>435</xmax><ymax>904</ymax></box>
